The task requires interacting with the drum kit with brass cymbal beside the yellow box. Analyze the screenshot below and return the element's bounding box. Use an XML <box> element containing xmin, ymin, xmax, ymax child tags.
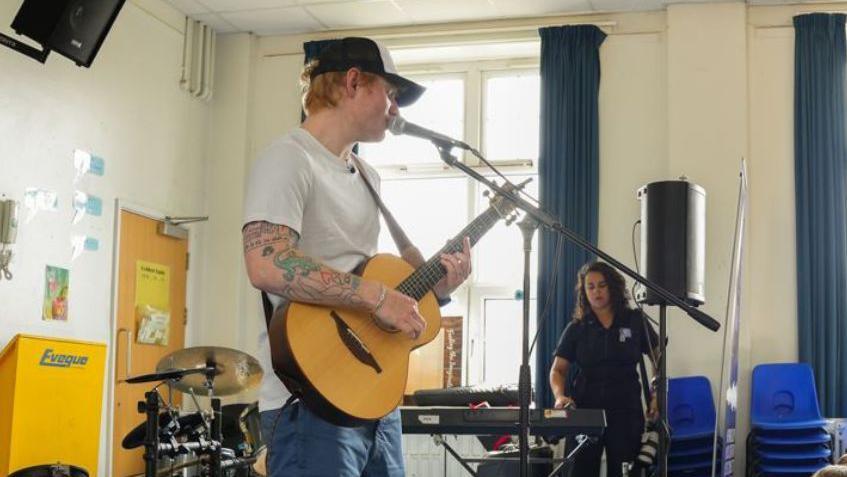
<box><xmin>122</xmin><ymin>346</ymin><xmax>264</xmax><ymax>477</ymax></box>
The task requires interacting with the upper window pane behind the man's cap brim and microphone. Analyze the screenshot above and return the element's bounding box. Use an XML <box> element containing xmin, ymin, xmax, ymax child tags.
<box><xmin>359</xmin><ymin>78</ymin><xmax>465</xmax><ymax>167</ymax></box>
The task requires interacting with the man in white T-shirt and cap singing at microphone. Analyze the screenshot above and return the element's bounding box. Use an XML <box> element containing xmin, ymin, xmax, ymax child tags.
<box><xmin>242</xmin><ymin>38</ymin><xmax>471</xmax><ymax>477</ymax></box>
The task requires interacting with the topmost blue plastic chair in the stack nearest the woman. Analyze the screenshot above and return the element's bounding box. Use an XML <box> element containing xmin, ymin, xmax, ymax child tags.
<box><xmin>668</xmin><ymin>376</ymin><xmax>715</xmax><ymax>438</ymax></box>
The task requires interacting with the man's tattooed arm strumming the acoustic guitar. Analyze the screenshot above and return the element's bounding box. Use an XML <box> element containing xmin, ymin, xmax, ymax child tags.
<box><xmin>241</xmin><ymin>222</ymin><xmax>426</xmax><ymax>338</ymax></box>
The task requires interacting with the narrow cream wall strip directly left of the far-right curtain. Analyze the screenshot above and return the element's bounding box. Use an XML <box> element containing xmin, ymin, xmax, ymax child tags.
<box><xmin>745</xmin><ymin>6</ymin><xmax>798</xmax><ymax>365</ymax></box>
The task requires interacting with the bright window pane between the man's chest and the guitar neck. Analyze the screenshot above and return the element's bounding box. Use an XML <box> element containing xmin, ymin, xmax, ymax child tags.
<box><xmin>379</xmin><ymin>178</ymin><xmax>468</xmax><ymax>259</ymax></box>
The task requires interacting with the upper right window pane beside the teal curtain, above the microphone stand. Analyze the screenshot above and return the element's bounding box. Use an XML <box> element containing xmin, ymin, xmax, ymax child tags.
<box><xmin>483</xmin><ymin>72</ymin><xmax>541</xmax><ymax>160</ymax></box>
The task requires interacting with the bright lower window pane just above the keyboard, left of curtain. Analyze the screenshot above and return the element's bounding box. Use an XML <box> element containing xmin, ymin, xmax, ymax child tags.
<box><xmin>483</xmin><ymin>298</ymin><xmax>537</xmax><ymax>386</ymax></box>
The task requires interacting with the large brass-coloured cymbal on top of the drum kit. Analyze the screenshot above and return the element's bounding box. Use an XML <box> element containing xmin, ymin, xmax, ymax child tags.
<box><xmin>156</xmin><ymin>346</ymin><xmax>262</xmax><ymax>396</ymax></box>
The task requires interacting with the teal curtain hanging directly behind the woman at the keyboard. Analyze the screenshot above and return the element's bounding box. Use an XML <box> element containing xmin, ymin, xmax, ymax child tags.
<box><xmin>535</xmin><ymin>25</ymin><xmax>606</xmax><ymax>408</ymax></box>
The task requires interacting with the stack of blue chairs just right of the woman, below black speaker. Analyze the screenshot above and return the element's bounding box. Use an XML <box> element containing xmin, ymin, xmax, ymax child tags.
<box><xmin>668</xmin><ymin>376</ymin><xmax>720</xmax><ymax>477</ymax></box>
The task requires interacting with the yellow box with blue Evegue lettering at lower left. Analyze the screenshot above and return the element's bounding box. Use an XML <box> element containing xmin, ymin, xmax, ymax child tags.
<box><xmin>0</xmin><ymin>334</ymin><xmax>106</xmax><ymax>477</ymax></box>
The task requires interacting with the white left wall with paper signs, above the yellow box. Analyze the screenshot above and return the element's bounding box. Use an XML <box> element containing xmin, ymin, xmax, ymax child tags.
<box><xmin>0</xmin><ymin>0</ymin><xmax>210</xmax><ymax>475</ymax></box>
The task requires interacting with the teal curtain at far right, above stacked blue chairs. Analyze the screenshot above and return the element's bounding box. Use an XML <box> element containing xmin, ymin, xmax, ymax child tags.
<box><xmin>794</xmin><ymin>14</ymin><xmax>847</xmax><ymax>417</ymax></box>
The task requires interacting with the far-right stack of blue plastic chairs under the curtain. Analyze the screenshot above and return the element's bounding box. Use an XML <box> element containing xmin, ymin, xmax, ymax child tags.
<box><xmin>747</xmin><ymin>363</ymin><xmax>832</xmax><ymax>477</ymax></box>
